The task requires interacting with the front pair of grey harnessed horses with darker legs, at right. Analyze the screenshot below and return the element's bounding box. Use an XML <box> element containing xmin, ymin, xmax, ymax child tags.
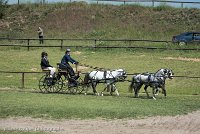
<box><xmin>129</xmin><ymin>69</ymin><xmax>174</xmax><ymax>100</ymax></box>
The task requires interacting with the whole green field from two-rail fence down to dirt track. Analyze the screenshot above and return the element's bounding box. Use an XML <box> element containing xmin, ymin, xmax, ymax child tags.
<box><xmin>0</xmin><ymin>46</ymin><xmax>200</xmax><ymax>119</ymax></box>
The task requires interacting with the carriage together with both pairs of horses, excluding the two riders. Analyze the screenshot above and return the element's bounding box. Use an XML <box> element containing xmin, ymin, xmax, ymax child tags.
<box><xmin>39</xmin><ymin>65</ymin><xmax>173</xmax><ymax>99</ymax></box>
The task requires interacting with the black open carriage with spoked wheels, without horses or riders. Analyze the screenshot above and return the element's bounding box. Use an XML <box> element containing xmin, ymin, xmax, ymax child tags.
<box><xmin>39</xmin><ymin>63</ymin><xmax>84</xmax><ymax>94</ymax></box>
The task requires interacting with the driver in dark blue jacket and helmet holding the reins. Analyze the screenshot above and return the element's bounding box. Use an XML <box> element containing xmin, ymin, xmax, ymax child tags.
<box><xmin>59</xmin><ymin>48</ymin><xmax>79</xmax><ymax>80</ymax></box>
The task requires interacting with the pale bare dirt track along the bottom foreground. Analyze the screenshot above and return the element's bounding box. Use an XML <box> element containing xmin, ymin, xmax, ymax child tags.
<box><xmin>0</xmin><ymin>111</ymin><xmax>200</xmax><ymax>134</ymax></box>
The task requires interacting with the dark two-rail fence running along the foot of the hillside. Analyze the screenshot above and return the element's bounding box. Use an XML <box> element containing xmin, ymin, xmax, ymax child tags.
<box><xmin>0</xmin><ymin>38</ymin><xmax>200</xmax><ymax>51</ymax></box>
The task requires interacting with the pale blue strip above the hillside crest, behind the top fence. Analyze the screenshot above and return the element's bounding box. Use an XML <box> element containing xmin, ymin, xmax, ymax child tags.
<box><xmin>5</xmin><ymin>0</ymin><xmax>200</xmax><ymax>8</ymax></box>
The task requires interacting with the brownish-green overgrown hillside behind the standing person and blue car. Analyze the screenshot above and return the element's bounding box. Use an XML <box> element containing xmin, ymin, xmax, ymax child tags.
<box><xmin>0</xmin><ymin>3</ymin><xmax>200</xmax><ymax>40</ymax></box>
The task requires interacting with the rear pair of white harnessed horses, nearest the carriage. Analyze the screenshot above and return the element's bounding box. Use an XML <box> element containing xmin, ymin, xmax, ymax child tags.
<box><xmin>84</xmin><ymin>69</ymin><xmax>127</xmax><ymax>96</ymax></box>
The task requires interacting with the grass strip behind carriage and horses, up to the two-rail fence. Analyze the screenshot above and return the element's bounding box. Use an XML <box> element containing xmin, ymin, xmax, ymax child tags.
<box><xmin>0</xmin><ymin>48</ymin><xmax>200</xmax><ymax>95</ymax></box>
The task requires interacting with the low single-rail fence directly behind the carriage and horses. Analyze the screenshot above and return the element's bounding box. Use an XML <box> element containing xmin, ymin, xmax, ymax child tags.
<box><xmin>0</xmin><ymin>71</ymin><xmax>200</xmax><ymax>89</ymax></box>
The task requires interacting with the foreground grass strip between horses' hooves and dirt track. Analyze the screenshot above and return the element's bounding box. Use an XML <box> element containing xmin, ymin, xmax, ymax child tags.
<box><xmin>0</xmin><ymin>91</ymin><xmax>200</xmax><ymax>119</ymax></box>
